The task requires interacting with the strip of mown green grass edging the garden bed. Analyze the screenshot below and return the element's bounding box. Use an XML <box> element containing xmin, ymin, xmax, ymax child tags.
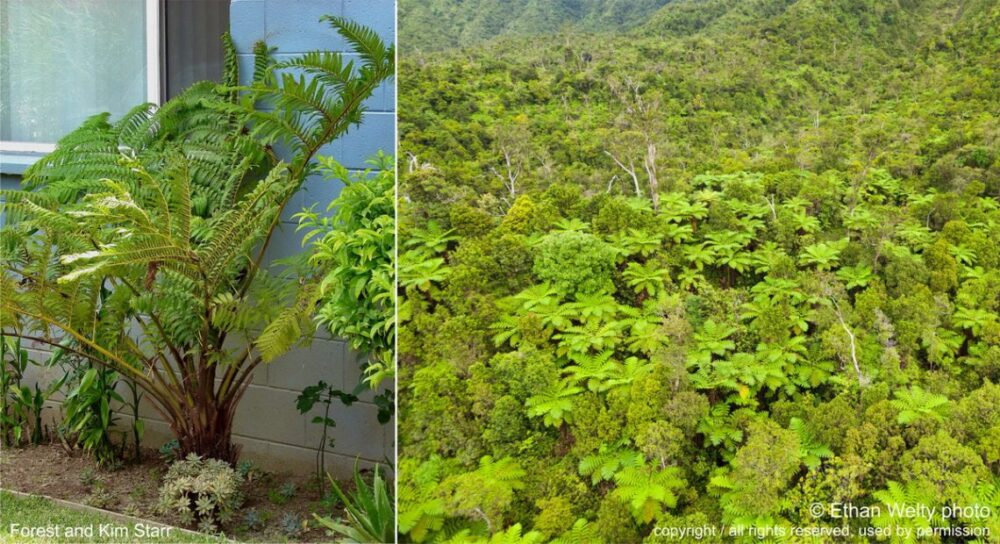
<box><xmin>0</xmin><ymin>491</ymin><xmax>226</xmax><ymax>544</ymax></box>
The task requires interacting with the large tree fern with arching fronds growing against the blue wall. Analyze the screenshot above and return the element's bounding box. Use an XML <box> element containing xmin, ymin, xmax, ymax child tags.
<box><xmin>0</xmin><ymin>17</ymin><xmax>394</xmax><ymax>462</ymax></box>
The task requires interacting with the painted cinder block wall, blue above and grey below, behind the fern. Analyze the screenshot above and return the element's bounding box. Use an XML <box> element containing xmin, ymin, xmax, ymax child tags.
<box><xmin>10</xmin><ymin>0</ymin><xmax>395</xmax><ymax>478</ymax></box>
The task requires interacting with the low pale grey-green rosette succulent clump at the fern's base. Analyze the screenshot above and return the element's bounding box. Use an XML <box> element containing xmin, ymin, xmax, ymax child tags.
<box><xmin>159</xmin><ymin>453</ymin><xmax>243</xmax><ymax>532</ymax></box>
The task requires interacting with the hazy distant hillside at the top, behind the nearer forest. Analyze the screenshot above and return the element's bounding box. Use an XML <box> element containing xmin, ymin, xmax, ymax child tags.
<box><xmin>399</xmin><ymin>0</ymin><xmax>670</xmax><ymax>52</ymax></box>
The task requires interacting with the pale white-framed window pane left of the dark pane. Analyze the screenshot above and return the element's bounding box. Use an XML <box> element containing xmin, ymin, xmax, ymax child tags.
<box><xmin>0</xmin><ymin>0</ymin><xmax>160</xmax><ymax>151</ymax></box>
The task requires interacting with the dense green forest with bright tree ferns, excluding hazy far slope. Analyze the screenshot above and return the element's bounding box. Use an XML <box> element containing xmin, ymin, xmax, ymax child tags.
<box><xmin>399</xmin><ymin>0</ymin><xmax>1000</xmax><ymax>543</ymax></box>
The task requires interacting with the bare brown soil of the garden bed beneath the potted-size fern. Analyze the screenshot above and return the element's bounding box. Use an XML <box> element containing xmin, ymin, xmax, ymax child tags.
<box><xmin>0</xmin><ymin>444</ymin><xmax>352</xmax><ymax>542</ymax></box>
